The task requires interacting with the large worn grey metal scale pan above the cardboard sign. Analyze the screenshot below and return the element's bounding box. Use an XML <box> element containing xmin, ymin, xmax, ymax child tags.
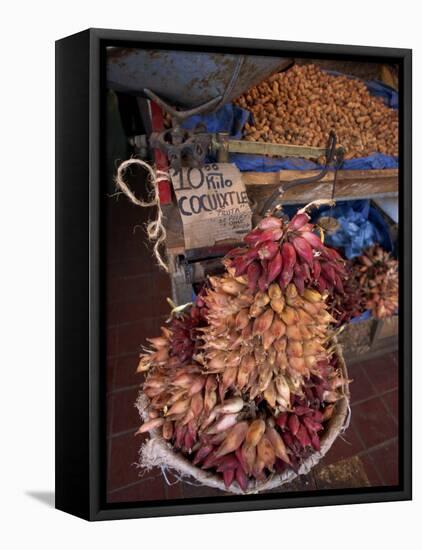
<box><xmin>107</xmin><ymin>47</ymin><xmax>292</xmax><ymax>109</ymax></box>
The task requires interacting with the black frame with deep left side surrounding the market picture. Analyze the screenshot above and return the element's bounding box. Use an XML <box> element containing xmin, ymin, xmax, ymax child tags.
<box><xmin>56</xmin><ymin>29</ymin><xmax>412</xmax><ymax>520</ymax></box>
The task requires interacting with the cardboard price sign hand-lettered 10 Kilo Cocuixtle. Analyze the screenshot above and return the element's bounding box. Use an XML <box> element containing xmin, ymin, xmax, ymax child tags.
<box><xmin>171</xmin><ymin>163</ymin><xmax>252</xmax><ymax>249</ymax></box>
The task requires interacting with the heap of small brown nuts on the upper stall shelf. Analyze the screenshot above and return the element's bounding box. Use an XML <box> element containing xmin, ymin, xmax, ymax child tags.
<box><xmin>234</xmin><ymin>65</ymin><xmax>398</xmax><ymax>159</ymax></box>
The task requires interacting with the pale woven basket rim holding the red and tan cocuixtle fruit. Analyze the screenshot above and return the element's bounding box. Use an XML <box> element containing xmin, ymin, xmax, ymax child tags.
<box><xmin>136</xmin><ymin>344</ymin><xmax>350</xmax><ymax>494</ymax></box>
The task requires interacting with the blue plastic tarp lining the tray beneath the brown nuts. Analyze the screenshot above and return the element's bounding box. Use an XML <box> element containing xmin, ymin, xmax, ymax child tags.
<box><xmin>182</xmin><ymin>71</ymin><xmax>398</xmax><ymax>172</ymax></box>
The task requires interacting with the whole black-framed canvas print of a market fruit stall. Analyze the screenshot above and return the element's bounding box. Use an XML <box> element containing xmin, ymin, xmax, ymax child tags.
<box><xmin>56</xmin><ymin>29</ymin><xmax>411</xmax><ymax>520</ymax></box>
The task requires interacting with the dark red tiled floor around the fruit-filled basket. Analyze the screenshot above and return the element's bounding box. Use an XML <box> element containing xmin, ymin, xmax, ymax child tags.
<box><xmin>106</xmin><ymin>197</ymin><xmax>398</xmax><ymax>503</ymax></box>
